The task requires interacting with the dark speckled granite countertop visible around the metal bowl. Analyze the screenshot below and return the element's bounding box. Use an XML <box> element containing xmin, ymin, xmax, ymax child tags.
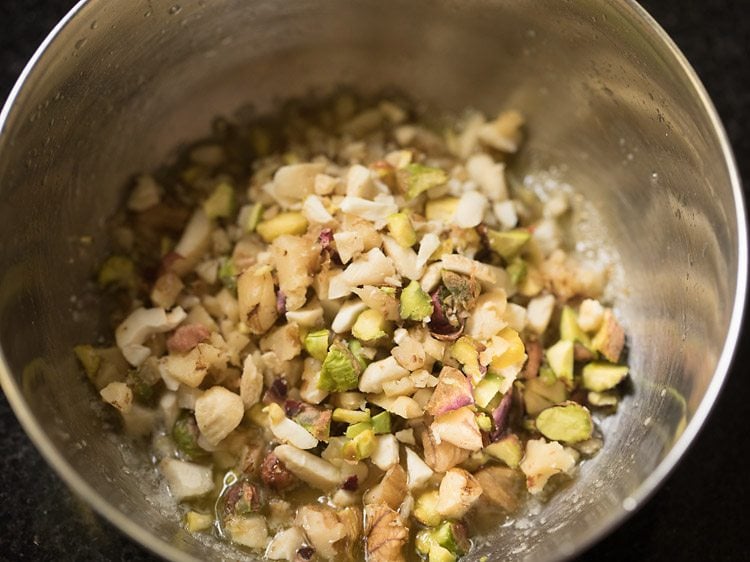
<box><xmin>0</xmin><ymin>0</ymin><xmax>750</xmax><ymax>561</ymax></box>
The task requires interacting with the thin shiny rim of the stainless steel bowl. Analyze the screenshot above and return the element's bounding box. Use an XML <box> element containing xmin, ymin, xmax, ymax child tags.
<box><xmin>0</xmin><ymin>0</ymin><xmax>748</xmax><ymax>560</ymax></box>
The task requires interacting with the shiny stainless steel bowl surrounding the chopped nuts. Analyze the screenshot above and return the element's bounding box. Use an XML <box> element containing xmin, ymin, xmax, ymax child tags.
<box><xmin>0</xmin><ymin>0</ymin><xmax>747</xmax><ymax>560</ymax></box>
